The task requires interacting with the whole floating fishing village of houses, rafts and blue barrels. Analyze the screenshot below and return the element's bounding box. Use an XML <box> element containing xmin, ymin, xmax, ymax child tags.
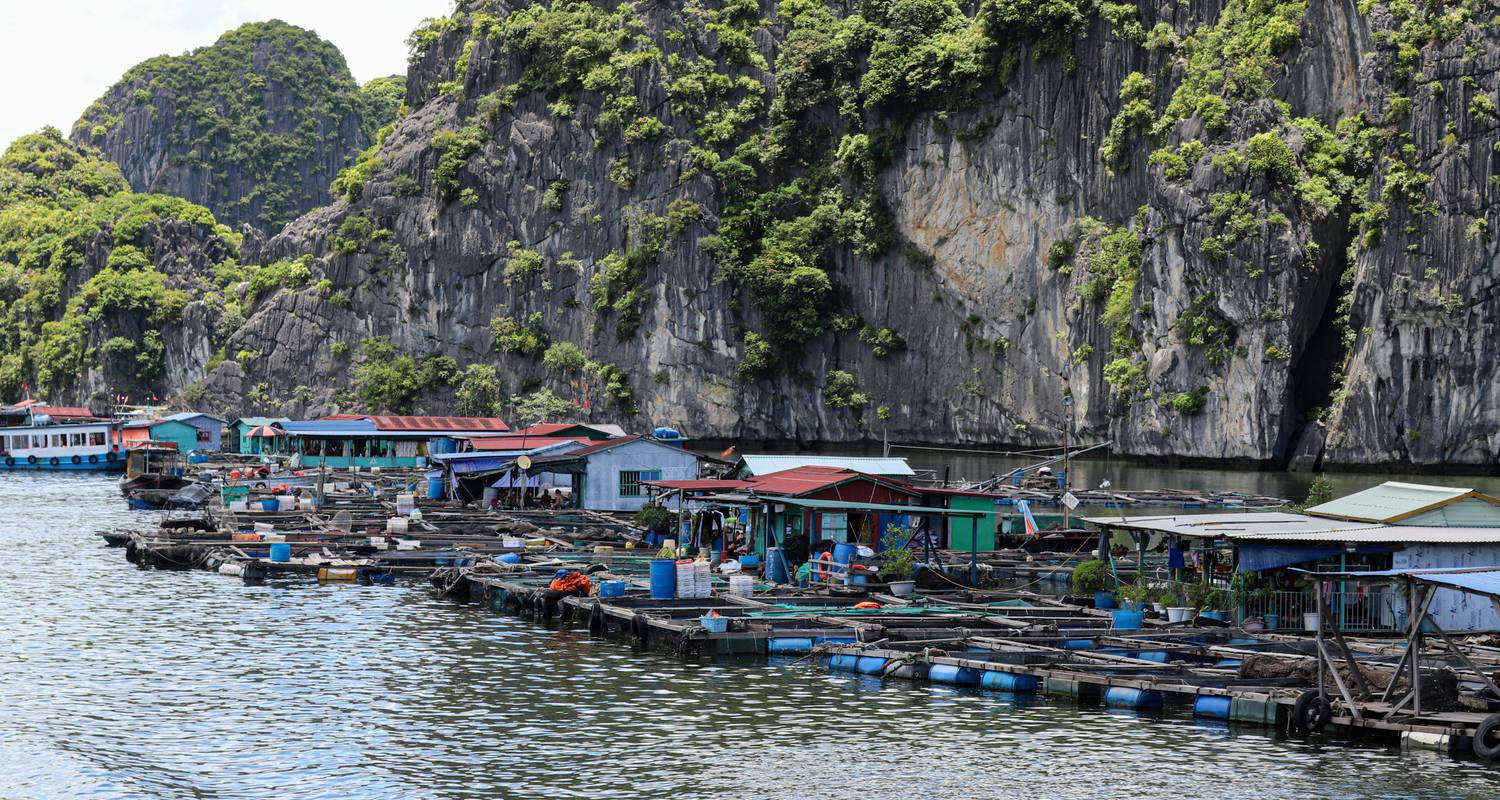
<box><xmin>0</xmin><ymin>402</ymin><xmax>1500</xmax><ymax>761</ymax></box>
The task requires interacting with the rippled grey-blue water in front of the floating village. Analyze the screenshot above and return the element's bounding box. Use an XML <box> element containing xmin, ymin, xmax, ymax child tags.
<box><xmin>0</xmin><ymin>476</ymin><xmax>1500</xmax><ymax>800</ymax></box>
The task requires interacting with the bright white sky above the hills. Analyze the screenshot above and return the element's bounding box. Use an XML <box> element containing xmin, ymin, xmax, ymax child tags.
<box><xmin>0</xmin><ymin>0</ymin><xmax>453</xmax><ymax>147</ymax></box>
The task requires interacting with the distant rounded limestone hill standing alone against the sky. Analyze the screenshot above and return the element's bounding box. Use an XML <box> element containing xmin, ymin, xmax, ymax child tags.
<box><xmin>72</xmin><ymin>21</ymin><xmax>395</xmax><ymax>233</ymax></box>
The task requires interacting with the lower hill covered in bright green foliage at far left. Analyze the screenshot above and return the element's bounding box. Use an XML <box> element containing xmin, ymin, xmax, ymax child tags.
<box><xmin>0</xmin><ymin>128</ymin><xmax>237</xmax><ymax>401</ymax></box>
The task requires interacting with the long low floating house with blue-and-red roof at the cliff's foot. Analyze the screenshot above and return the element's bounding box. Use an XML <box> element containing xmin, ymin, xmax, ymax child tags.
<box><xmin>262</xmin><ymin>414</ymin><xmax>509</xmax><ymax>468</ymax></box>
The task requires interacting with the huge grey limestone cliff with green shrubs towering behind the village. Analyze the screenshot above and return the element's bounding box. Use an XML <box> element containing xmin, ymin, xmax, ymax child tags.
<box><xmin>46</xmin><ymin>0</ymin><xmax>1500</xmax><ymax>468</ymax></box>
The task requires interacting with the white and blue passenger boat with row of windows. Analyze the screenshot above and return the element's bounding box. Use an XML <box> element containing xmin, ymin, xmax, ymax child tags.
<box><xmin>0</xmin><ymin>402</ymin><xmax>125</xmax><ymax>471</ymax></box>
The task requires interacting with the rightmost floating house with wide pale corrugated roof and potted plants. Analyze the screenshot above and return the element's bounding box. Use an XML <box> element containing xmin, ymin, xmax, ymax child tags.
<box><xmin>1088</xmin><ymin>482</ymin><xmax>1500</xmax><ymax>630</ymax></box>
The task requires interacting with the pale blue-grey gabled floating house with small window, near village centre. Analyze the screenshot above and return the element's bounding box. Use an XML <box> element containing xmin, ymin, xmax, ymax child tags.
<box><xmin>527</xmin><ymin>435</ymin><xmax>699</xmax><ymax>512</ymax></box>
